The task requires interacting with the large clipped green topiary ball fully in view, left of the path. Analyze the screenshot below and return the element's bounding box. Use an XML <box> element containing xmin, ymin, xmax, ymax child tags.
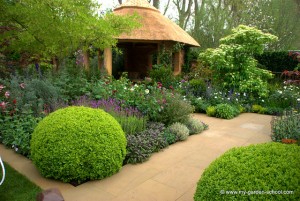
<box><xmin>31</xmin><ymin>107</ymin><xmax>126</xmax><ymax>183</ymax></box>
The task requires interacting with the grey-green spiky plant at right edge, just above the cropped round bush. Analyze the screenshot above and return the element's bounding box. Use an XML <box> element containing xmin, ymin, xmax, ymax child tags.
<box><xmin>271</xmin><ymin>112</ymin><xmax>300</xmax><ymax>142</ymax></box>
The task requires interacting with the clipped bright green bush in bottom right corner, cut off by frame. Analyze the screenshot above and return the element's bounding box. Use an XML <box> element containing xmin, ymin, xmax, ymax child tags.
<box><xmin>194</xmin><ymin>143</ymin><xmax>300</xmax><ymax>201</ymax></box>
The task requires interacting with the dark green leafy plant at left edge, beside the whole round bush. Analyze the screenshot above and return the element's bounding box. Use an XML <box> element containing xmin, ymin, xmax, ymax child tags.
<box><xmin>0</xmin><ymin>113</ymin><xmax>41</xmax><ymax>157</ymax></box>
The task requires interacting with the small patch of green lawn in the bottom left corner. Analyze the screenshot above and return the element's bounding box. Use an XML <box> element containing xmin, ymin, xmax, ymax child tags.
<box><xmin>0</xmin><ymin>163</ymin><xmax>42</xmax><ymax>201</ymax></box>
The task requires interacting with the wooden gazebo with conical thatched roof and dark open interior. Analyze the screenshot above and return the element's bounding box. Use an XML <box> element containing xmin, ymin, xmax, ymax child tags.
<box><xmin>104</xmin><ymin>0</ymin><xmax>200</xmax><ymax>79</ymax></box>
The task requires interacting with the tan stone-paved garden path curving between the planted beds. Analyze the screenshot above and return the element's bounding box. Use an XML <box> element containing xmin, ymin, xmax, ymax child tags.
<box><xmin>0</xmin><ymin>113</ymin><xmax>271</xmax><ymax>201</ymax></box>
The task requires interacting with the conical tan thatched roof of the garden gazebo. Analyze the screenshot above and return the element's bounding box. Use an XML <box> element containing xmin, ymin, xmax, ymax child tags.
<box><xmin>114</xmin><ymin>0</ymin><xmax>200</xmax><ymax>47</ymax></box>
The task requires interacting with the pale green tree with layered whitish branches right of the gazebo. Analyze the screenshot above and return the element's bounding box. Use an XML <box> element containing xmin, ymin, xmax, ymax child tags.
<box><xmin>200</xmin><ymin>25</ymin><xmax>278</xmax><ymax>97</ymax></box>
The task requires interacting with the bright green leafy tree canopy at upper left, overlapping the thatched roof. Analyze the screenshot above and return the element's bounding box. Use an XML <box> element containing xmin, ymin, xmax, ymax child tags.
<box><xmin>0</xmin><ymin>0</ymin><xmax>137</xmax><ymax>68</ymax></box>
